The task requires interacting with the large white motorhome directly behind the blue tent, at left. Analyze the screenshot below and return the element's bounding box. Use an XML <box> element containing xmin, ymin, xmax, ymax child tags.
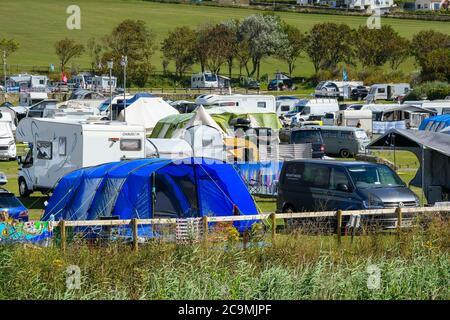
<box><xmin>16</xmin><ymin>118</ymin><xmax>145</xmax><ymax>197</ymax></box>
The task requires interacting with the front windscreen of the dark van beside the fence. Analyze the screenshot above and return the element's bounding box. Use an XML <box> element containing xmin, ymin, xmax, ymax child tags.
<box><xmin>348</xmin><ymin>164</ymin><xmax>405</xmax><ymax>189</ymax></box>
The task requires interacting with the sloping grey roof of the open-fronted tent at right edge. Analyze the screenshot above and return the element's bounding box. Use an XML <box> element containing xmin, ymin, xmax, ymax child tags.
<box><xmin>367</xmin><ymin>129</ymin><xmax>450</xmax><ymax>157</ymax></box>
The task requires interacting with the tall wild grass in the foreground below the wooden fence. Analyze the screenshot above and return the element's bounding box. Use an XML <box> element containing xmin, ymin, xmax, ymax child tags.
<box><xmin>0</xmin><ymin>216</ymin><xmax>450</xmax><ymax>299</ymax></box>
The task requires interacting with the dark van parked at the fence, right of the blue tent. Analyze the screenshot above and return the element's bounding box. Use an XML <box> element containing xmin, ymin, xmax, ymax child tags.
<box><xmin>277</xmin><ymin>159</ymin><xmax>420</xmax><ymax>218</ymax></box>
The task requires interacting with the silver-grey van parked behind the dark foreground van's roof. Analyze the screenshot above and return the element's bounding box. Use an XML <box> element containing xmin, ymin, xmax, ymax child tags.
<box><xmin>316</xmin><ymin>126</ymin><xmax>370</xmax><ymax>158</ymax></box>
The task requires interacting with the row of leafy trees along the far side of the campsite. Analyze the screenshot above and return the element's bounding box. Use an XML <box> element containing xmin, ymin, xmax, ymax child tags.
<box><xmin>9</xmin><ymin>14</ymin><xmax>450</xmax><ymax>86</ymax></box>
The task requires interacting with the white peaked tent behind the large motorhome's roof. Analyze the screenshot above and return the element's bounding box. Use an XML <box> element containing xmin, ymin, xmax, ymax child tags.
<box><xmin>117</xmin><ymin>97</ymin><xmax>179</xmax><ymax>132</ymax></box>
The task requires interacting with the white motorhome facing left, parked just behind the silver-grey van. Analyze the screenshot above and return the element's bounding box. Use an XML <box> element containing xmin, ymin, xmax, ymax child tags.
<box><xmin>286</xmin><ymin>99</ymin><xmax>339</xmax><ymax>125</ymax></box>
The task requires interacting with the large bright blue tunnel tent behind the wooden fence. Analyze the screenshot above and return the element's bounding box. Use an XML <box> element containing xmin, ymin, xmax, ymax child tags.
<box><xmin>42</xmin><ymin>158</ymin><xmax>258</xmax><ymax>231</ymax></box>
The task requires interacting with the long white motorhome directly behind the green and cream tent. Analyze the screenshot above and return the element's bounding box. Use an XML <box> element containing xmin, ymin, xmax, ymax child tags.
<box><xmin>195</xmin><ymin>94</ymin><xmax>276</xmax><ymax>112</ymax></box>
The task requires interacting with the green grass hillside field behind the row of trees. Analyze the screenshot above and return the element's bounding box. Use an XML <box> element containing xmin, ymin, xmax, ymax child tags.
<box><xmin>0</xmin><ymin>0</ymin><xmax>450</xmax><ymax>76</ymax></box>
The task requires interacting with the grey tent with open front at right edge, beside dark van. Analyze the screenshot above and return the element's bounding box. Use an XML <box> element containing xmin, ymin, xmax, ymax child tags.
<box><xmin>367</xmin><ymin>129</ymin><xmax>450</xmax><ymax>204</ymax></box>
